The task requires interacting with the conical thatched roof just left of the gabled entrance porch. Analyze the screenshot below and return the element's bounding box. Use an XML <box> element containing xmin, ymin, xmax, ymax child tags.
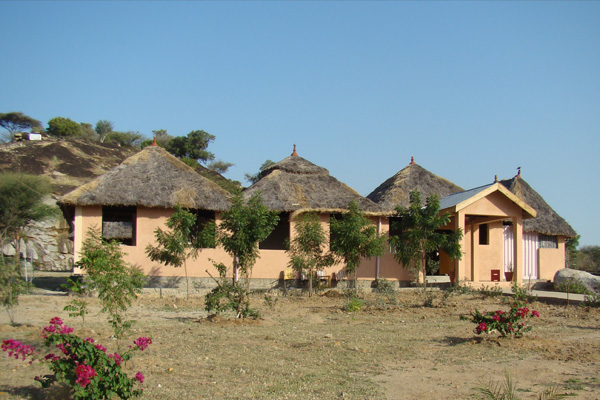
<box><xmin>367</xmin><ymin>159</ymin><xmax>463</xmax><ymax>211</ymax></box>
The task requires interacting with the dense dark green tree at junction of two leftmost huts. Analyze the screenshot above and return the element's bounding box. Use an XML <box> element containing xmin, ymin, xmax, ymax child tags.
<box><xmin>217</xmin><ymin>193</ymin><xmax>279</xmax><ymax>287</ymax></box>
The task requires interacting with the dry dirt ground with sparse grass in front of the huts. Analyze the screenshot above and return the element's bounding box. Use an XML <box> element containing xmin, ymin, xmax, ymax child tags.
<box><xmin>0</xmin><ymin>282</ymin><xmax>600</xmax><ymax>400</ymax></box>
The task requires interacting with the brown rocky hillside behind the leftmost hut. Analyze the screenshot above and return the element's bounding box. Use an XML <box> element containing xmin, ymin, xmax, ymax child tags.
<box><xmin>0</xmin><ymin>139</ymin><xmax>135</xmax><ymax>277</ymax></box>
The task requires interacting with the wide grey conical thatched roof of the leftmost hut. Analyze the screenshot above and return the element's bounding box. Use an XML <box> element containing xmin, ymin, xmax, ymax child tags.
<box><xmin>59</xmin><ymin>146</ymin><xmax>230</xmax><ymax>211</ymax></box>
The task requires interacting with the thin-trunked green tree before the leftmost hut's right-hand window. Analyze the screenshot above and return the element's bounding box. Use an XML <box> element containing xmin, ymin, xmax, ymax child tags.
<box><xmin>146</xmin><ymin>205</ymin><xmax>215</xmax><ymax>299</ymax></box>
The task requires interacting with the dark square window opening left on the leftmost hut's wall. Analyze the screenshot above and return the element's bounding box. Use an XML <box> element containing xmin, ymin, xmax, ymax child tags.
<box><xmin>102</xmin><ymin>206</ymin><xmax>137</xmax><ymax>246</ymax></box>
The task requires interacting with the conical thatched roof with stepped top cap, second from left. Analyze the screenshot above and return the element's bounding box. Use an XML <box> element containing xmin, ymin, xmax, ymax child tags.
<box><xmin>244</xmin><ymin>151</ymin><xmax>383</xmax><ymax>215</ymax></box>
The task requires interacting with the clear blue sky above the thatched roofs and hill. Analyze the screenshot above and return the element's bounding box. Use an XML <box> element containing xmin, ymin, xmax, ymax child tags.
<box><xmin>0</xmin><ymin>1</ymin><xmax>600</xmax><ymax>245</ymax></box>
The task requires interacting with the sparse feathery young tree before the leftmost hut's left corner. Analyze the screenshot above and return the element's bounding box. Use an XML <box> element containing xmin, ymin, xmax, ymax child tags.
<box><xmin>78</xmin><ymin>227</ymin><xmax>145</xmax><ymax>339</ymax></box>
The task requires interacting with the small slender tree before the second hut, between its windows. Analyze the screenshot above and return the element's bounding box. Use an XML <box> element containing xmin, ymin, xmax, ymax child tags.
<box><xmin>288</xmin><ymin>212</ymin><xmax>334</xmax><ymax>297</ymax></box>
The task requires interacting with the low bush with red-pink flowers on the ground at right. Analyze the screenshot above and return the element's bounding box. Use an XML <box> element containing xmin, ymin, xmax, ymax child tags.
<box><xmin>461</xmin><ymin>303</ymin><xmax>540</xmax><ymax>337</ymax></box>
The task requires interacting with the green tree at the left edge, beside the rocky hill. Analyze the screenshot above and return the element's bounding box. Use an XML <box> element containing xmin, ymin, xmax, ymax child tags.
<box><xmin>0</xmin><ymin>172</ymin><xmax>58</xmax><ymax>322</ymax></box>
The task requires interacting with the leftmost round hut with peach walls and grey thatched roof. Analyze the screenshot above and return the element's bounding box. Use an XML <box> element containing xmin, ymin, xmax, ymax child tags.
<box><xmin>59</xmin><ymin>146</ymin><xmax>231</xmax><ymax>282</ymax></box>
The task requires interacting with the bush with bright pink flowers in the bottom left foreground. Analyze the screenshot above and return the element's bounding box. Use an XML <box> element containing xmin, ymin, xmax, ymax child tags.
<box><xmin>2</xmin><ymin>317</ymin><xmax>152</xmax><ymax>399</ymax></box>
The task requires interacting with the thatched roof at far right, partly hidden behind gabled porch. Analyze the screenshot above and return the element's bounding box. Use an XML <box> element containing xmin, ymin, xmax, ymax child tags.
<box><xmin>500</xmin><ymin>174</ymin><xmax>577</xmax><ymax>237</ymax></box>
